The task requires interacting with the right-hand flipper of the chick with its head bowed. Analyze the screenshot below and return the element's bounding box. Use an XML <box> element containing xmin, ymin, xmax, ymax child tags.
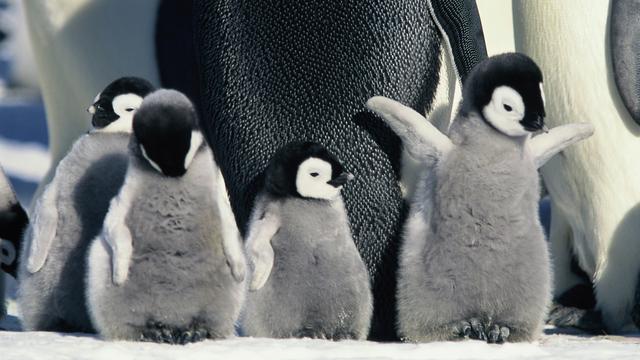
<box><xmin>215</xmin><ymin>170</ymin><xmax>246</xmax><ymax>282</ymax></box>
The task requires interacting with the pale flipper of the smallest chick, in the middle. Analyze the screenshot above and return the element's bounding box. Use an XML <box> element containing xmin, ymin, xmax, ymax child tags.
<box><xmin>247</xmin><ymin>201</ymin><xmax>280</xmax><ymax>291</ymax></box>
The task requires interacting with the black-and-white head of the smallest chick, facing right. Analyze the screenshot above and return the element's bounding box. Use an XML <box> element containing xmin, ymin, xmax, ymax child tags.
<box><xmin>265</xmin><ymin>142</ymin><xmax>353</xmax><ymax>200</ymax></box>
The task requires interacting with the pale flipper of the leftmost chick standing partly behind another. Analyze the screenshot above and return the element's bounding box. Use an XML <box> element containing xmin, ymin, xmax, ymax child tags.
<box><xmin>27</xmin><ymin>177</ymin><xmax>58</xmax><ymax>274</ymax></box>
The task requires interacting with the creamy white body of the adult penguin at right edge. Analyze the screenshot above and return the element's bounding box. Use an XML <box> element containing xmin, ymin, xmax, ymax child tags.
<box><xmin>513</xmin><ymin>0</ymin><xmax>640</xmax><ymax>332</ymax></box>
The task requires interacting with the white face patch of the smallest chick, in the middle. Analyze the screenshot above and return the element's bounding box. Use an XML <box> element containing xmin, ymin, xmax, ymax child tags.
<box><xmin>296</xmin><ymin>157</ymin><xmax>342</xmax><ymax>200</ymax></box>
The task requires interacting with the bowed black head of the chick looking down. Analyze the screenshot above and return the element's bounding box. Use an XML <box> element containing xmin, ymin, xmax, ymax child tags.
<box><xmin>133</xmin><ymin>90</ymin><xmax>202</xmax><ymax>177</ymax></box>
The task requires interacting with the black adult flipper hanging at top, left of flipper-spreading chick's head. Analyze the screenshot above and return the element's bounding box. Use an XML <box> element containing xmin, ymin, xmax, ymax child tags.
<box><xmin>428</xmin><ymin>0</ymin><xmax>487</xmax><ymax>82</ymax></box>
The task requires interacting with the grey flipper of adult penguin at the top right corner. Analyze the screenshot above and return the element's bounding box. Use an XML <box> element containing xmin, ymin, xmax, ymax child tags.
<box><xmin>609</xmin><ymin>0</ymin><xmax>640</xmax><ymax>124</ymax></box>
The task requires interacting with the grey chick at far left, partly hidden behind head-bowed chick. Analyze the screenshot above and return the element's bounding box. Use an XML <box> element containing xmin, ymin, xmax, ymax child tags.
<box><xmin>18</xmin><ymin>77</ymin><xmax>152</xmax><ymax>332</ymax></box>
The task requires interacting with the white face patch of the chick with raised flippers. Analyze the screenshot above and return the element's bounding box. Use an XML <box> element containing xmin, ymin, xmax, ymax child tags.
<box><xmin>482</xmin><ymin>86</ymin><xmax>529</xmax><ymax>136</ymax></box>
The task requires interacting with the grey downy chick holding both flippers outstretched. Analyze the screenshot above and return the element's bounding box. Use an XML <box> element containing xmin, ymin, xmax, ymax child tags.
<box><xmin>367</xmin><ymin>53</ymin><xmax>593</xmax><ymax>343</ymax></box>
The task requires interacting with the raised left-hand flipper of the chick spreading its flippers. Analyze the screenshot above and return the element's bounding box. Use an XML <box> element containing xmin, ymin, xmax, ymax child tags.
<box><xmin>367</xmin><ymin>96</ymin><xmax>454</xmax><ymax>160</ymax></box>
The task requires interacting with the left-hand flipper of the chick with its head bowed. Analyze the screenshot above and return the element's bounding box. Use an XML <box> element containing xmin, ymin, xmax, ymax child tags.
<box><xmin>101</xmin><ymin>169</ymin><xmax>137</xmax><ymax>285</ymax></box>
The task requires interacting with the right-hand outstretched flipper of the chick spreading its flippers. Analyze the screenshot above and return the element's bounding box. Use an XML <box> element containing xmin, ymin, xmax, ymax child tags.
<box><xmin>529</xmin><ymin>123</ymin><xmax>594</xmax><ymax>168</ymax></box>
